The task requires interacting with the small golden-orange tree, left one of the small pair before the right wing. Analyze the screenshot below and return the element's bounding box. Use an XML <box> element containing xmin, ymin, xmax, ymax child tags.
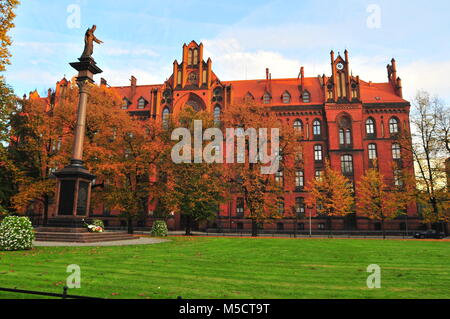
<box><xmin>305</xmin><ymin>161</ymin><xmax>354</xmax><ymax>235</ymax></box>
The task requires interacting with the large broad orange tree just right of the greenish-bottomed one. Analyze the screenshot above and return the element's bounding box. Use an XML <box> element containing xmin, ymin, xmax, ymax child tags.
<box><xmin>222</xmin><ymin>99</ymin><xmax>302</xmax><ymax>236</ymax></box>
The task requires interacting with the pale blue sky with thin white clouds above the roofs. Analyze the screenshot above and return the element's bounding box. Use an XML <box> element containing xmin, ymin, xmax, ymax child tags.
<box><xmin>6</xmin><ymin>0</ymin><xmax>450</xmax><ymax>101</ymax></box>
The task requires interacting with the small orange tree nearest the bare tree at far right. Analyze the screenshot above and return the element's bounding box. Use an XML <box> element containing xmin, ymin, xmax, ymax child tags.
<box><xmin>356</xmin><ymin>168</ymin><xmax>407</xmax><ymax>238</ymax></box>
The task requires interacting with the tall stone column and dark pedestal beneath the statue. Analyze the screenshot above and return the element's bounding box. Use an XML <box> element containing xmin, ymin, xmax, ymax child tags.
<box><xmin>54</xmin><ymin>57</ymin><xmax>102</xmax><ymax>225</ymax></box>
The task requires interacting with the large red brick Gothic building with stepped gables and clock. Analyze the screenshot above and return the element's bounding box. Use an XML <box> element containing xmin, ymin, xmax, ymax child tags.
<box><xmin>48</xmin><ymin>41</ymin><xmax>420</xmax><ymax>231</ymax></box>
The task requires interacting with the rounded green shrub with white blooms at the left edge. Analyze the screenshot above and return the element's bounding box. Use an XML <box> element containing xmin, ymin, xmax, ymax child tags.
<box><xmin>0</xmin><ymin>216</ymin><xmax>34</xmax><ymax>250</ymax></box>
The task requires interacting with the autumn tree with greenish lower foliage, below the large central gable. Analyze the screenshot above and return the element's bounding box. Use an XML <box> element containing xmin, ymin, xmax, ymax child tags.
<box><xmin>158</xmin><ymin>107</ymin><xmax>224</xmax><ymax>235</ymax></box>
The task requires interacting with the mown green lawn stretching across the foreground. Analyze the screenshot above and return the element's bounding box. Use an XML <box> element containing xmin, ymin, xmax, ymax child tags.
<box><xmin>0</xmin><ymin>237</ymin><xmax>450</xmax><ymax>298</ymax></box>
